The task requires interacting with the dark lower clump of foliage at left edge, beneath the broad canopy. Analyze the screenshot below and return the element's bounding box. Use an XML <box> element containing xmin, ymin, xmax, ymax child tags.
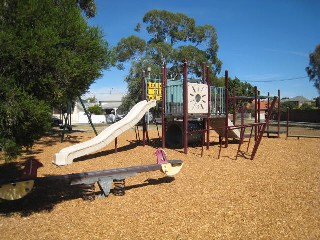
<box><xmin>0</xmin><ymin>78</ymin><xmax>51</xmax><ymax>159</ymax></box>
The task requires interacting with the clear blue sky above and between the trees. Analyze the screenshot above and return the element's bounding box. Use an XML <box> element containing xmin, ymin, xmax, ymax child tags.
<box><xmin>85</xmin><ymin>0</ymin><xmax>320</xmax><ymax>100</ymax></box>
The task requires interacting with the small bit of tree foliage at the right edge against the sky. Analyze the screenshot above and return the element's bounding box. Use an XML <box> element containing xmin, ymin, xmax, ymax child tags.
<box><xmin>306</xmin><ymin>44</ymin><xmax>320</xmax><ymax>94</ymax></box>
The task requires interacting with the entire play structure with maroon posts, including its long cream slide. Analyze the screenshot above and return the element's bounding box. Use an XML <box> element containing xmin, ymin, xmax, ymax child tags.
<box><xmin>53</xmin><ymin>59</ymin><xmax>280</xmax><ymax>165</ymax></box>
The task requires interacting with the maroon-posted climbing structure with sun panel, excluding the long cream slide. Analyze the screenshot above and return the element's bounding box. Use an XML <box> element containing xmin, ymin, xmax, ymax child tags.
<box><xmin>143</xmin><ymin>62</ymin><xmax>280</xmax><ymax>159</ymax></box>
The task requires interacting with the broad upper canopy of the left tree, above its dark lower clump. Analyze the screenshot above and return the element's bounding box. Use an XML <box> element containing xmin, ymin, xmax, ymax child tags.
<box><xmin>0</xmin><ymin>0</ymin><xmax>112</xmax><ymax>106</ymax></box>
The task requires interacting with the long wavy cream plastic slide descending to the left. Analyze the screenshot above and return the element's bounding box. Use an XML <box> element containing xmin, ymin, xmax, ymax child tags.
<box><xmin>53</xmin><ymin>100</ymin><xmax>156</xmax><ymax>166</ymax></box>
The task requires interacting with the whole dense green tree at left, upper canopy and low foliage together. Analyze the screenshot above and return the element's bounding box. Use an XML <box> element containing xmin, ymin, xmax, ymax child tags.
<box><xmin>0</xmin><ymin>0</ymin><xmax>110</xmax><ymax>161</ymax></box>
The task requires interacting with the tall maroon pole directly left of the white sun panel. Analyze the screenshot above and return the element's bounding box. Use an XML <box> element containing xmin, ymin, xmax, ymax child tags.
<box><xmin>183</xmin><ymin>61</ymin><xmax>188</xmax><ymax>154</ymax></box>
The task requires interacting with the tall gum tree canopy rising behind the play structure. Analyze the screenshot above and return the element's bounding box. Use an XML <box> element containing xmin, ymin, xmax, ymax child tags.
<box><xmin>114</xmin><ymin>10</ymin><xmax>222</xmax><ymax>109</ymax></box>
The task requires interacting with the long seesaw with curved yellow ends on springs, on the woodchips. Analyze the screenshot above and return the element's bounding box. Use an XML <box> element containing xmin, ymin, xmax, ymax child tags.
<box><xmin>0</xmin><ymin>148</ymin><xmax>183</xmax><ymax>200</ymax></box>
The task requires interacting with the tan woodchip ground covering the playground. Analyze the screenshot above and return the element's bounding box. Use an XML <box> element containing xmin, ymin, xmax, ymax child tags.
<box><xmin>0</xmin><ymin>126</ymin><xmax>320</xmax><ymax>240</ymax></box>
